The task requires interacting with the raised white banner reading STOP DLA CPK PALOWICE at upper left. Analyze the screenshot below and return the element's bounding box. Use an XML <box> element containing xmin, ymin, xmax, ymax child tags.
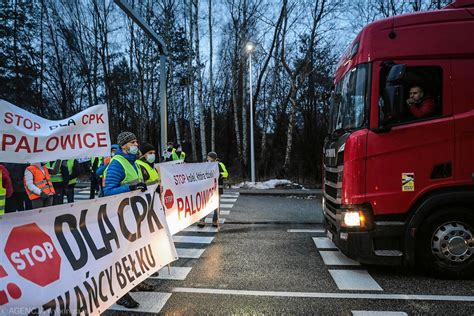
<box><xmin>0</xmin><ymin>100</ymin><xmax>110</xmax><ymax>163</ymax></box>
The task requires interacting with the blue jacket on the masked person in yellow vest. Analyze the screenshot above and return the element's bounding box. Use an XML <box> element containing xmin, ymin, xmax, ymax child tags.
<box><xmin>104</xmin><ymin>149</ymin><xmax>137</xmax><ymax>196</ymax></box>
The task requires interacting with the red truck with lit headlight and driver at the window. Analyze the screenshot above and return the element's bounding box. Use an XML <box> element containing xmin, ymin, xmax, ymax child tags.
<box><xmin>322</xmin><ymin>0</ymin><xmax>474</xmax><ymax>278</ymax></box>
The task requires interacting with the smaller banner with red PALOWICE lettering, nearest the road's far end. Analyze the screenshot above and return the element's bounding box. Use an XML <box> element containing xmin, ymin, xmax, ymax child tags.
<box><xmin>159</xmin><ymin>162</ymin><xmax>219</xmax><ymax>235</ymax></box>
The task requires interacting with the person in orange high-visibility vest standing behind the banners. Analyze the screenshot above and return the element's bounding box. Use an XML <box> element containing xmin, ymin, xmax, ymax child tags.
<box><xmin>23</xmin><ymin>162</ymin><xmax>55</xmax><ymax>209</ymax></box>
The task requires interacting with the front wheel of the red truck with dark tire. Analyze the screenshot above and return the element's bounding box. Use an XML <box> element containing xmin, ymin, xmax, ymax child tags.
<box><xmin>417</xmin><ymin>207</ymin><xmax>474</xmax><ymax>279</ymax></box>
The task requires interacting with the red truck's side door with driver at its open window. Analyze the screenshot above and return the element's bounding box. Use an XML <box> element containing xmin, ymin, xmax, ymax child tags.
<box><xmin>366</xmin><ymin>60</ymin><xmax>454</xmax><ymax>215</ymax></box>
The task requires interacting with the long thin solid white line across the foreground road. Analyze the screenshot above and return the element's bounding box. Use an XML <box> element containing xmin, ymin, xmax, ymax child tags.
<box><xmin>172</xmin><ymin>287</ymin><xmax>474</xmax><ymax>302</ymax></box>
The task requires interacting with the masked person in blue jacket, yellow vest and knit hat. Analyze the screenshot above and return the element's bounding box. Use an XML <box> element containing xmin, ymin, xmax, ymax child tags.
<box><xmin>104</xmin><ymin>132</ymin><xmax>155</xmax><ymax>308</ymax></box>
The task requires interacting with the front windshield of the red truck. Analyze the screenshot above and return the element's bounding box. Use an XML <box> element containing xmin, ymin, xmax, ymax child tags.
<box><xmin>329</xmin><ymin>64</ymin><xmax>369</xmax><ymax>134</ymax></box>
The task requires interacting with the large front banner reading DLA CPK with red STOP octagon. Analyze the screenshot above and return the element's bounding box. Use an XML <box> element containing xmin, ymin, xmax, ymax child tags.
<box><xmin>0</xmin><ymin>185</ymin><xmax>177</xmax><ymax>315</ymax></box>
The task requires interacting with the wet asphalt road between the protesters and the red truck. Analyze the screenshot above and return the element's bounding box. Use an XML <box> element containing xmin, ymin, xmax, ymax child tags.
<box><xmin>90</xmin><ymin>190</ymin><xmax>474</xmax><ymax>315</ymax></box>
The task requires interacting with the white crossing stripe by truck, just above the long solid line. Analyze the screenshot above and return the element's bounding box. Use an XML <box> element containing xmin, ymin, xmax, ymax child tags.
<box><xmin>329</xmin><ymin>270</ymin><xmax>383</xmax><ymax>291</ymax></box>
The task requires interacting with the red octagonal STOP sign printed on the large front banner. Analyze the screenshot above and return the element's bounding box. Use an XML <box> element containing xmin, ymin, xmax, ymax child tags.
<box><xmin>5</xmin><ymin>224</ymin><xmax>61</xmax><ymax>286</ymax></box>
